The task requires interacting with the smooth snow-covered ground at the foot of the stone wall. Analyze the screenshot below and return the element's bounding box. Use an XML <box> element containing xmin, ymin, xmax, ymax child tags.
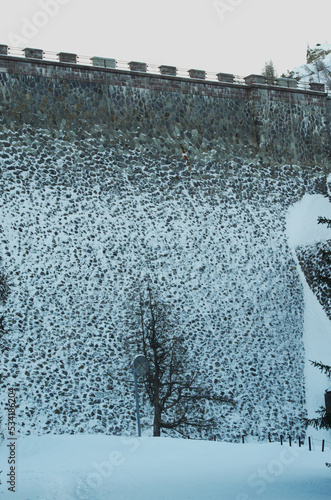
<box><xmin>0</xmin><ymin>435</ymin><xmax>331</xmax><ymax>500</ymax></box>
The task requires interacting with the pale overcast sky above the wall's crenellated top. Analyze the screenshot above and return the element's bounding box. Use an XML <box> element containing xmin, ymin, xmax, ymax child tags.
<box><xmin>0</xmin><ymin>0</ymin><xmax>331</xmax><ymax>76</ymax></box>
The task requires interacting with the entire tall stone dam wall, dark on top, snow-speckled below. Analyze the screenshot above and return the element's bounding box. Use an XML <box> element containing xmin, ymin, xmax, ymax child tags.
<box><xmin>0</xmin><ymin>50</ymin><xmax>330</xmax><ymax>440</ymax></box>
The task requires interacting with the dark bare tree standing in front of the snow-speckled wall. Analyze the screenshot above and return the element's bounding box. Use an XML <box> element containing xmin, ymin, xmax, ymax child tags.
<box><xmin>127</xmin><ymin>286</ymin><xmax>233</xmax><ymax>436</ymax></box>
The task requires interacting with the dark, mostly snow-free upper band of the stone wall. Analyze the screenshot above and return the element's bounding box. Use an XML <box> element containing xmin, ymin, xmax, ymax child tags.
<box><xmin>0</xmin><ymin>56</ymin><xmax>329</xmax><ymax>169</ymax></box>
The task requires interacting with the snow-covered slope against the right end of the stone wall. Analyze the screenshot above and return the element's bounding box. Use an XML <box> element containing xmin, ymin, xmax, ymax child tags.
<box><xmin>287</xmin><ymin>191</ymin><xmax>331</xmax><ymax>439</ymax></box>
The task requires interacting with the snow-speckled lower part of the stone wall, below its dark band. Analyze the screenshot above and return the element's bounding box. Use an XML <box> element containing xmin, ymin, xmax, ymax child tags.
<box><xmin>0</xmin><ymin>124</ymin><xmax>324</xmax><ymax>440</ymax></box>
